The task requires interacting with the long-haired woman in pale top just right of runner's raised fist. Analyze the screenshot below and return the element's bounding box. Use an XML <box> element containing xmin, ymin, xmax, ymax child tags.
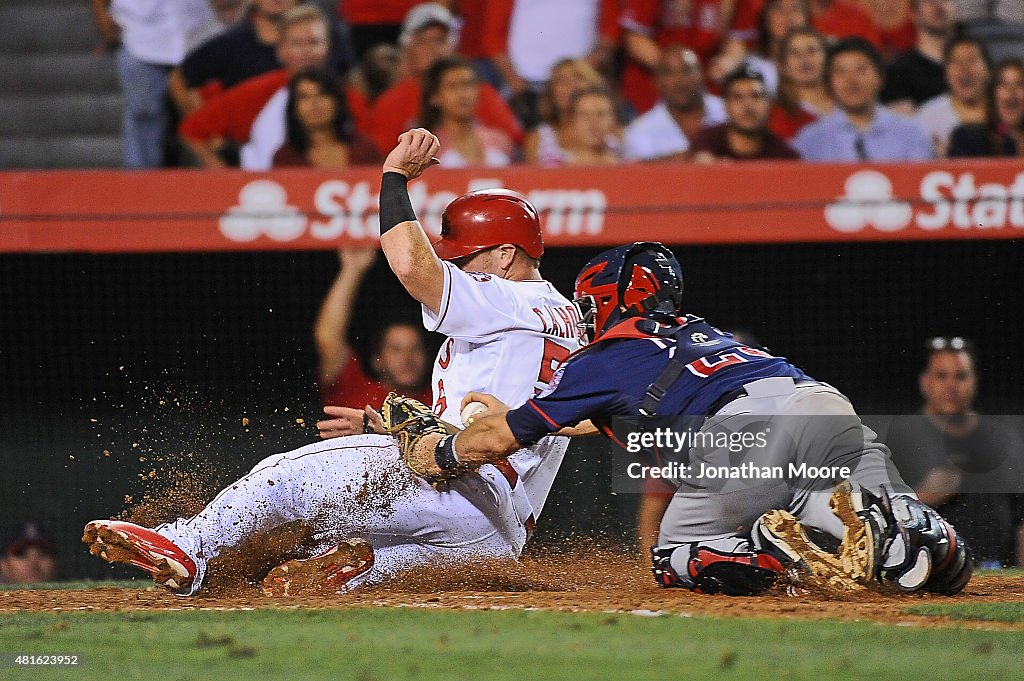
<box><xmin>420</xmin><ymin>56</ymin><xmax>514</xmax><ymax>168</ymax></box>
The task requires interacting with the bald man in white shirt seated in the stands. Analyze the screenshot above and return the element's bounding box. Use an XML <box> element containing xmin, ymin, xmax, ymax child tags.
<box><xmin>625</xmin><ymin>47</ymin><xmax>725</xmax><ymax>161</ymax></box>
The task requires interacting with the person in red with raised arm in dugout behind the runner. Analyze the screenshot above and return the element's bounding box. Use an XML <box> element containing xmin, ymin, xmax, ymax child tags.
<box><xmin>314</xmin><ymin>248</ymin><xmax>433</xmax><ymax>409</ymax></box>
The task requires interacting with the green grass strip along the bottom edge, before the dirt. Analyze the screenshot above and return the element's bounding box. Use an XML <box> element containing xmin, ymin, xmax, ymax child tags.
<box><xmin>0</xmin><ymin>608</ymin><xmax>1022</xmax><ymax>681</ymax></box>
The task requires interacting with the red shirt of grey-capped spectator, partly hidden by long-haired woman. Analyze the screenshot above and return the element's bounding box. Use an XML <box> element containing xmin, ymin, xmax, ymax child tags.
<box><xmin>367</xmin><ymin>78</ymin><xmax>523</xmax><ymax>153</ymax></box>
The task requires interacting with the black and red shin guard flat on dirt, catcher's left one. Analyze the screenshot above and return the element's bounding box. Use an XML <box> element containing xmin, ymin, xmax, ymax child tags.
<box><xmin>650</xmin><ymin>544</ymin><xmax>786</xmax><ymax>596</ymax></box>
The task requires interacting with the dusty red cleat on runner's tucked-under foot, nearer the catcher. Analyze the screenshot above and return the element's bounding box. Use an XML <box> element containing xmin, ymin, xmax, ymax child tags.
<box><xmin>263</xmin><ymin>539</ymin><xmax>374</xmax><ymax>596</ymax></box>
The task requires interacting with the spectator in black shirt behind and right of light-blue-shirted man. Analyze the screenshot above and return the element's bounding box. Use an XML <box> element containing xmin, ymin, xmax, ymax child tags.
<box><xmin>881</xmin><ymin>0</ymin><xmax>956</xmax><ymax>115</ymax></box>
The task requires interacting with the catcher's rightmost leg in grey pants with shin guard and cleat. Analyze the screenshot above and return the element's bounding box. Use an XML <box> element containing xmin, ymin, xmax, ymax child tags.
<box><xmin>768</xmin><ymin>385</ymin><xmax>973</xmax><ymax>593</ymax></box>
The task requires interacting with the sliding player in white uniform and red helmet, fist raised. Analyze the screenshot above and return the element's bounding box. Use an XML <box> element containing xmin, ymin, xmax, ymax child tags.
<box><xmin>83</xmin><ymin>129</ymin><xmax>580</xmax><ymax>595</ymax></box>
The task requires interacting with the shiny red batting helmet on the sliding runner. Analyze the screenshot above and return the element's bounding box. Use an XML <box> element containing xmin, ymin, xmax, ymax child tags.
<box><xmin>433</xmin><ymin>189</ymin><xmax>544</xmax><ymax>260</ymax></box>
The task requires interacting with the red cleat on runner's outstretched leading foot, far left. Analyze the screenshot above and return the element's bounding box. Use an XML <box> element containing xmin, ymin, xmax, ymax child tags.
<box><xmin>82</xmin><ymin>520</ymin><xmax>197</xmax><ymax>594</ymax></box>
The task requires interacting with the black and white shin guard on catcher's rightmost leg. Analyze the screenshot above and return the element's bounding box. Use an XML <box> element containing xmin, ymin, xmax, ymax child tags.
<box><xmin>876</xmin><ymin>495</ymin><xmax>974</xmax><ymax>596</ymax></box>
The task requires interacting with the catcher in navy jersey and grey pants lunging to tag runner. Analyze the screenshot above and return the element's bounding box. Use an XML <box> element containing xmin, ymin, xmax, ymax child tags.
<box><xmin>402</xmin><ymin>243</ymin><xmax>973</xmax><ymax>595</ymax></box>
